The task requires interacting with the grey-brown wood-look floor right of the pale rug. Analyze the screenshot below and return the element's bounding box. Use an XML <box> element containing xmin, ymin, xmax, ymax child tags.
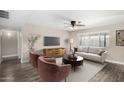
<box><xmin>89</xmin><ymin>63</ymin><xmax>124</xmax><ymax>82</ymax></box>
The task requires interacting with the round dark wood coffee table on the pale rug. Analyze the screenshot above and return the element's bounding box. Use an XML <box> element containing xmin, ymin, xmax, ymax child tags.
<box><xmin>62</xmin><ymin>54</ymin><xmax>84</xmax><ymax>71</ymax></box>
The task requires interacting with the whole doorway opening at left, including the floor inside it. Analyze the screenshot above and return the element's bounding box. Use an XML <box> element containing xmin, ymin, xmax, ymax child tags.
<box><xmin>1</xmin><ymin>30</ymin><xmax>20</xmax><ymax>64</ymax></box>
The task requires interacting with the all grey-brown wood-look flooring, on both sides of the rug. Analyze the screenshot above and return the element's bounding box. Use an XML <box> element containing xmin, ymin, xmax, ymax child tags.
<box><xmin>0</xmin><ymin>59</ymin><xmax>124</xmax><ymax>82</ymax></box>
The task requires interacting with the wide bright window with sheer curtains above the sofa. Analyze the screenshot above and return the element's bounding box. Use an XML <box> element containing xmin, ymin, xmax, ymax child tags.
<box><xmin>78</xmin><ymin>32</ymin><xmax>109</xmax><ymax>47</ymax></box>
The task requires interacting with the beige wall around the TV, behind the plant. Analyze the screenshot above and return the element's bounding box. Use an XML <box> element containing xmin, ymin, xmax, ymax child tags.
<box><xmin>21</xmin><ymin>24</ymin><xmax>69</xmax><ymax>63</ymax></box>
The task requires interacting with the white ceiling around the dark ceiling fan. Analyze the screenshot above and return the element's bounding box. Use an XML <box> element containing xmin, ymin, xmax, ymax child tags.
<box><xmin>0</xmin><ymin>10</ymin><xmax>124</xmax><ymax>30</ymax></box>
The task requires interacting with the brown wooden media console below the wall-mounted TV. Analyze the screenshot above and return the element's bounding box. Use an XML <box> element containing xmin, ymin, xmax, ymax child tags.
<box><xmin>43</xmin><ymin>48</ymin><xmax>66</xmax><ymax>57</ymax></box>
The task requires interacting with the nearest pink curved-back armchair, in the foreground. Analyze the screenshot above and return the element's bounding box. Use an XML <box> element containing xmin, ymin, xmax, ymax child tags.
<box><xmin>38</xmin><ymin>56</ymin><xmax>71</xmax><ymax>82</ymax></box>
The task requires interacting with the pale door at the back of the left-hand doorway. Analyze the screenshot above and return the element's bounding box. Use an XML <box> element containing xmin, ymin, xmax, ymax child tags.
<box><xmin>2</xmin><ymin>31</ymin><xmax>18</xmax><ymax>58</ymax></box>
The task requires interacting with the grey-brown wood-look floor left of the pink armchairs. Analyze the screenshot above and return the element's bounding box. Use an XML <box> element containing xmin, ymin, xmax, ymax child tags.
<box><xmin>0</xmin><ymin>60</ymin><xmax>40</xmax><ymax>82</ymax></box>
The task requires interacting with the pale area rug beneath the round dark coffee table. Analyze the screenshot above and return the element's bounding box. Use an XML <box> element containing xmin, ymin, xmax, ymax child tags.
<box><xmin>57</xmin><ymin>58</ymin><xmax>106</xmax><ymax>82</ymax></box>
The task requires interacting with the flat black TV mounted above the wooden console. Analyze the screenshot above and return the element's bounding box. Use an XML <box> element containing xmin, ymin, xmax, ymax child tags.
<box><xmin>44</xmin><ymin>36</ymin><xmax>60</xmax><ymax>46</ymax></box>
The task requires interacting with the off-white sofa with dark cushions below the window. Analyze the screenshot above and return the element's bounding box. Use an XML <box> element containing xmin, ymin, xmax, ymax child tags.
<box><xmin>76</xmin><ymin>46</ymin><xmax>107</xmax><ymax>63</ymax></box>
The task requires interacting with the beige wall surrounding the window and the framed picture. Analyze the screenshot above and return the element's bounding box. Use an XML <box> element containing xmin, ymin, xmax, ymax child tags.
<box><xmin>70</xmin><ymin>24</ymin><xmax>124</xmax><ymax>63</ymax></box>
